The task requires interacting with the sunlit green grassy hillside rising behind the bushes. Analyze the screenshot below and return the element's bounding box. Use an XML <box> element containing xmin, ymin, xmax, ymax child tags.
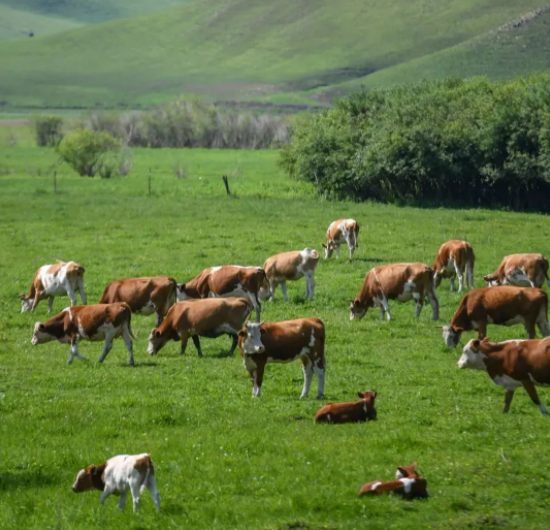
<box><xmin>0</xmin><ymin>0</ymin><xmax>547</xmax><ymax>106</ymax></box>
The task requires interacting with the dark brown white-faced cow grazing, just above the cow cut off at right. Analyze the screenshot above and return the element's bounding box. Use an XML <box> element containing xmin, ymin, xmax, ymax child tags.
<box><xmin>441</xmin><ymin>286</ymin><xmax>550</xmax><ymax>348</ymax></box>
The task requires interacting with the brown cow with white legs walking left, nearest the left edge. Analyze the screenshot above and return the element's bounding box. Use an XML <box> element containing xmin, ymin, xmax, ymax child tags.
<box><xmin>31</xmin><ymin>303</ymin><xmax>134</xmax><ymax>365</ymax></box>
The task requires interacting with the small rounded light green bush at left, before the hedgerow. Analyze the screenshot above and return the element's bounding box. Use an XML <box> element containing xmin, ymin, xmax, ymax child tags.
<box><xmin>57</xmin><ymin>129</ymin><xmax>120</xmax><ymax>177</ymax></box>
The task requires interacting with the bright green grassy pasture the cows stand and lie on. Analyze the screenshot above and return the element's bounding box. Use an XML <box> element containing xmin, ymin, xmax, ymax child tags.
<box><xmin>0</xmin><ymin>147</ymin><xmax>550</xmax><ymax>530</ymax></box>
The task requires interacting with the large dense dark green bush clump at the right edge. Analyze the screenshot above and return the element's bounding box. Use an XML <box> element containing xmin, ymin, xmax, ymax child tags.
<box><xmin>281</xmin><ymin>75</ymin><xmax>550</xmax><ymax>212</ymax></box>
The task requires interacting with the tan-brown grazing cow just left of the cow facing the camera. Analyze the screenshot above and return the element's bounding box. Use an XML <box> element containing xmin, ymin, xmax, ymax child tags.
<box><xmin>147</xmin><ymin>298</ymin><xmax>252</xmax><ymax>357</ymax></box>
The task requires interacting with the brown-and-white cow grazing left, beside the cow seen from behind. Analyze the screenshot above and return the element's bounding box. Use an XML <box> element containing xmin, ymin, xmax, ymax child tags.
<box><xmin>350</xmin><ymin>263</ymin><xmax>439</xmax><ymax>320</ymax></box>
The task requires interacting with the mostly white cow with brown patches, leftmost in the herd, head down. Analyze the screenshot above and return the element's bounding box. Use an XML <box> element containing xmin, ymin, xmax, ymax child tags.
<box><xmin>19</xmin><ymin>261</ymin><xmax>87</xmax><ymax>313</ymax></box>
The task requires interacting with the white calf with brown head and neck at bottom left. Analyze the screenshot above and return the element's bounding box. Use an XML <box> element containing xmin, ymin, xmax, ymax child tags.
<box><xmin>73</xmin><ymin>453</ymin><xmax>160</xmax><ymax>513</ymax></box>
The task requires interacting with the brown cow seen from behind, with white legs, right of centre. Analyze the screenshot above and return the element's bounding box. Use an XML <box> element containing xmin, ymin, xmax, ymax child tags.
<box><xmin>433</xmin><ymin>239</ymin><xmax>475</xmax><ymax>293</ymax></box>
